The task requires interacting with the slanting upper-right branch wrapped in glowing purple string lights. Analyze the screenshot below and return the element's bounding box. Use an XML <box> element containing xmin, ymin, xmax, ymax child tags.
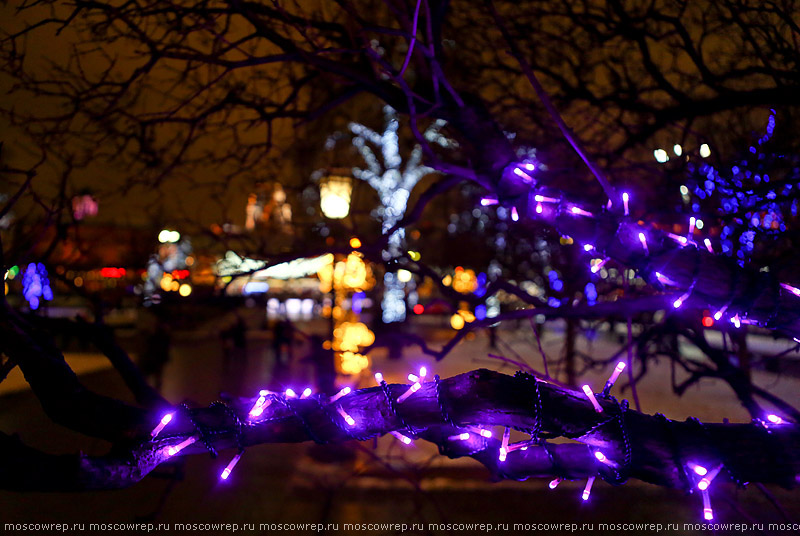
<box><xmin>481</xmin><ymin>162</ymin><xmax>800</xmax><ymax>338</ymax></box>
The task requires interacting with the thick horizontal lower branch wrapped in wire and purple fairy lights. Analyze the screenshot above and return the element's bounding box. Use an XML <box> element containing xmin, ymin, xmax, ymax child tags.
<box><xmin>0</xmin><ymin>370</ymin><xmax>800</xmax><ymax>490</ymax></box>
